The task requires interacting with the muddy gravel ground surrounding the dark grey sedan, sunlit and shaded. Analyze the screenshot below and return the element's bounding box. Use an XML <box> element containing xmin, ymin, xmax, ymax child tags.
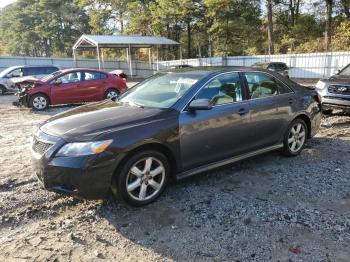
<box><xmin>0</xmin><ymin>88</ymin><xmax>350</xmax><ymax>261</ymax></box>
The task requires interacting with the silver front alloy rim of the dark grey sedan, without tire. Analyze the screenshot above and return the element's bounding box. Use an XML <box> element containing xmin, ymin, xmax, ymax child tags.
<box><xmin>126</xmin><ymin>157</ymin><xmax>165</xmax><ymax>201</ymax></box>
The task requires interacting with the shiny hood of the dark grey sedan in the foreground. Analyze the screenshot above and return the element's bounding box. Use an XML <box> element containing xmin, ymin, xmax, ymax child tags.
<box><xmin>40</xmin><ymin>100</ymin><xmax>174</xmax><ymax>141</ymax></box>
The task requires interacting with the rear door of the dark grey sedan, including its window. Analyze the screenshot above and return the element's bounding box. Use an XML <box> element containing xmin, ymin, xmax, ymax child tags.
<box><xmin>244</xmin><ymin>72</ymin><xmax>296</xmax><ymax>149</ymax></box>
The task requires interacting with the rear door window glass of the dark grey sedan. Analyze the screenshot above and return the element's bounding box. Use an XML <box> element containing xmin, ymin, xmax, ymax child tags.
<box><xmin>244</xmin><ymin>72</ymin><xmax>292</xmax><ymax>99</ymax></box>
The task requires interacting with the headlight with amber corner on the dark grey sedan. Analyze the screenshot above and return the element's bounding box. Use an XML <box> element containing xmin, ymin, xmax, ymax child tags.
<box><xmin>56</xmin><ymin>139</ymin><xmax>113</xmax><ymax>156</ymax></box>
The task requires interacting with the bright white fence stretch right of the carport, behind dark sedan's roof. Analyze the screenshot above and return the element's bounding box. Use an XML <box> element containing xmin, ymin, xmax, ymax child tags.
<box><xmin>159</xmin><ymin>52</ymin><xmax>350</xmax><ymax>78</ymax></box>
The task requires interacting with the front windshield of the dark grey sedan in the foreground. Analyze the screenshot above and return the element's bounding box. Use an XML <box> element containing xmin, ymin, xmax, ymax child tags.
<box><xmin>119</xmin><ymin>71</ymin><xmax>204</xmax><ymax>108</ymax></box>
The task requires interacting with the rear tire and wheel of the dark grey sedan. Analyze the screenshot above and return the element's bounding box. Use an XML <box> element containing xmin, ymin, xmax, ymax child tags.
<box><xmin>282</xmin><ymin>118</ymin><xmax>308</xmax><ymax>156</ymax></box>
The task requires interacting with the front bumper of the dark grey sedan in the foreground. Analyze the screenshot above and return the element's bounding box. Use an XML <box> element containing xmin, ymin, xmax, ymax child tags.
<box><xmin>31</xmin><ymin>131</ymin><xmax>116</xmax><ymax>199</ymax></box>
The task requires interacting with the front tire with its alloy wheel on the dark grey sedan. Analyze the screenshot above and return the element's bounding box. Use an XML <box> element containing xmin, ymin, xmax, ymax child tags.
<box><xmin>112</xmin><ymin>150</ymin><xmax>170</xmax><ymax>206</ymax></box>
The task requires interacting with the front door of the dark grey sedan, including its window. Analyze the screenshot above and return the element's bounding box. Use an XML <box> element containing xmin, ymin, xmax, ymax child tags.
<box><xmin>179</xmin><ymin>72</ymin><xmax>250</xmax><ymax>171</ymax></box>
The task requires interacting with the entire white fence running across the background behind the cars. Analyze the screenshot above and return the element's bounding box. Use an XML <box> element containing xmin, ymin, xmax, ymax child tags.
<box><xmin>0</xmin><ymin>52</ymin><xmax>350</xmax><ymax>78</ymax></box>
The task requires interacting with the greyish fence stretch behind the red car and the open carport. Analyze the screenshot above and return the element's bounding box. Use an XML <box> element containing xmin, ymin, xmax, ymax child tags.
<box><xmin>0</xmin><ymin>56</ymin><xmax>156</xmax><ymax>78</ymax></box>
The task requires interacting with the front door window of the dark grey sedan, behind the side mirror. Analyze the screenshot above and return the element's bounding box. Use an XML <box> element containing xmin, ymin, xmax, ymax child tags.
<box><xmin>196</xmin><ymin>73</ymin><xmax>243</xmax><ymax>106</ymax></box>
